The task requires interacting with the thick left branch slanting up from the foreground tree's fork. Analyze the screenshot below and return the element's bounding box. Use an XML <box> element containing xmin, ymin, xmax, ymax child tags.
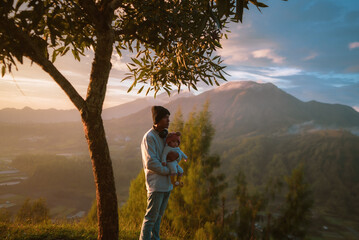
<box><xmin>0</xmin><ymin>19</ymin><xmax>86</xmax><ymax>112</ymax></box>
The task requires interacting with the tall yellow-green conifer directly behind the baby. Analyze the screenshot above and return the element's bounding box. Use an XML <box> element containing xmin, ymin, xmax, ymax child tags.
<box><xmin>166</xmin><ymin>102</ymin><xmax>226</xmax><ymax>239</ymax></box>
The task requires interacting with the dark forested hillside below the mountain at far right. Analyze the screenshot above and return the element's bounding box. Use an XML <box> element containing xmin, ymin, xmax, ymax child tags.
<box><xmin>221</xmin><ymin>130</ymin><xmax>359</xmax><ymax>219</ymax></box>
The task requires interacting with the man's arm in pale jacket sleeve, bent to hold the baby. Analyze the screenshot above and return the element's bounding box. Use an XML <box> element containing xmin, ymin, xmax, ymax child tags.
<box><xmin>144</xmin><ymin>136</ymin><xmax>170</xmax><ymax>176</ymax></box>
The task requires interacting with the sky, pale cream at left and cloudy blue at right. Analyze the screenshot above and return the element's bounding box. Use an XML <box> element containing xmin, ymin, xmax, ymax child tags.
<box><xmin>0</xmin><ymin>0</ymin><xmax>359</xmax><ymax>111</ymax></box>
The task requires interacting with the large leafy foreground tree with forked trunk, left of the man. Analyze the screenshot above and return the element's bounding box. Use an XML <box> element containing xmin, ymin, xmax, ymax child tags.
<box><xmin>0</xmin><ymin>0</ymin><xmax>282</xmax><ymax>240</ymax></box>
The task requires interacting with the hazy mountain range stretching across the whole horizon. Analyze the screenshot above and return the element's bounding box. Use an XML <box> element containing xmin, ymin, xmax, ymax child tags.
<box><xmin>0</xmin><ymin>81</ymin><xmax>359</xmax><ymax>155</ymax></box>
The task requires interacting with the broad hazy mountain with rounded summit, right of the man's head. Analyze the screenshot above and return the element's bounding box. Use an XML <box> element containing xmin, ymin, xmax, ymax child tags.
<box><xmin>108</xmin><ymin>81</ymin><xmax>359</xmax><ymax>139</ymax></box>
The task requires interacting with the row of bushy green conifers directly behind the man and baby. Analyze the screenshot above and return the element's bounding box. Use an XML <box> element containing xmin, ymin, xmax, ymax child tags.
<box><xmin>117</xmin><ymin>105</ymin><xmax>312</xmax><ymax>239</ymax></box>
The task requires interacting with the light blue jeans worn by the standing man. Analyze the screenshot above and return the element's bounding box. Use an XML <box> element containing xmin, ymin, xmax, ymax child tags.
<box><xmin>140</xmin><ymin>192</ymin><xmax>171</xmax><ymax>240</ymax></box>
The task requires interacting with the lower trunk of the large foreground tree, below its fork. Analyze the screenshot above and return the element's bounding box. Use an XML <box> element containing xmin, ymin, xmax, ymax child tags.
<box><xmin>82</xmin><ymin>112</ymin><xmax>119</xmax><ymax>240</ymax></box>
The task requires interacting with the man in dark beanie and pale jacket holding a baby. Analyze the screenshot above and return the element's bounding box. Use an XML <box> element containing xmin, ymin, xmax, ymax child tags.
<box><xmin>140</xmin><ymin>106</ymin><xmax>178</xmax><ymax>240</ymax></box>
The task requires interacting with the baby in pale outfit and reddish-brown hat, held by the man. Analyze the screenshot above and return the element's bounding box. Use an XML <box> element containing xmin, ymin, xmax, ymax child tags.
<box><xmin>162</xmin><ymin>132</ymin><xmax>188</xmax><ymax>186</ymax></box>
